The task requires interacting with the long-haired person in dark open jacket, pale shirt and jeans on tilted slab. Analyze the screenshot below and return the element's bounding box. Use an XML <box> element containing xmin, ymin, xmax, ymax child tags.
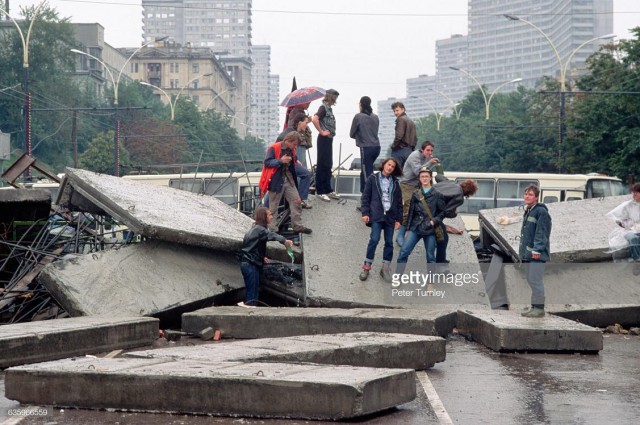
<box><xmin>360</xmin><ymin>158</ymin><xmax>402</xmax><ymax>282</ymax></box>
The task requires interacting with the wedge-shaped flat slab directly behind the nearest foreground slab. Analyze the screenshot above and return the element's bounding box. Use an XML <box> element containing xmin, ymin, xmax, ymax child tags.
<box><xmin>126</xmin><ymin>332</ymin><xmax>446</xmax><ymax>370</ymax></box>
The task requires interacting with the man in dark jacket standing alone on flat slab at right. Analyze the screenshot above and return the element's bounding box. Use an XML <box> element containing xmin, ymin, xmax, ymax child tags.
<box><xmin>519</xmin><ymin>185</ymin><xmax>551</xmax><ymax>317</ymax></box>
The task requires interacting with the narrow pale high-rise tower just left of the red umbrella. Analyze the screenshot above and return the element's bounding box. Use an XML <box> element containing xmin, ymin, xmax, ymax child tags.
<box><xmin>250</xmin><ymin>46</ymin><xmax>282</xmax><ymax>143</ymax></box>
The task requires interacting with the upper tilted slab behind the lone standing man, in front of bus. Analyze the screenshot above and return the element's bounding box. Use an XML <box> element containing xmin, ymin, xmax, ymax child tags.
<box><xmin>479</xmin><ymin>195</ymin><xmax>630</xmax><ymax>263</ymax></box>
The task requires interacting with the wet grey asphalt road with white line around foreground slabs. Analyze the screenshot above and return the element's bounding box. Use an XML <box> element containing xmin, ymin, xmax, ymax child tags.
<box><xmin>0</xmin><ymin>334</ymin><xmax>640</xmax><ymax>425</ymax></box>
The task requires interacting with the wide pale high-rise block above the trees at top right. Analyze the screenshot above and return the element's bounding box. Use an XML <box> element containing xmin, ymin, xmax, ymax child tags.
<box><xmin>464</xmin><ymin>0</ymin><xmax>613</xmax><ymax>90</ymax></box>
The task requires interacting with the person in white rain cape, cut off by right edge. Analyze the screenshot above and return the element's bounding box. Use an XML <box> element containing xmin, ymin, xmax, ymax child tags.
<box><xmin>607</xmin><ymin>183</ymin><xmax>640</xmax><ymax>276</ymax></box>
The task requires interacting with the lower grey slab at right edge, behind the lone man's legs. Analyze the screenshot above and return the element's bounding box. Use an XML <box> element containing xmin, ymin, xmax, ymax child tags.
<box><xmin>484</xmin><ymin>261</ymin><xmax>640</xmax><ymax>327</ymax></box>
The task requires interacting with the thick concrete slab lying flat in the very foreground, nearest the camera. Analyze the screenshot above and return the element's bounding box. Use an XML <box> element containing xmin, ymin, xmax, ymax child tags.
<box><xmin>5</xmin><ymin>358</ymin><xmax>416</xmax><ymax>420</ymax></box>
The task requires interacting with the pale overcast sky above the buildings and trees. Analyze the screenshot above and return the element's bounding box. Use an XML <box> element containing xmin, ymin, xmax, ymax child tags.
<box><xmin>12</xmin><ymin>0</ymin><xmax>640</xmax><ymax>165</ymax></box>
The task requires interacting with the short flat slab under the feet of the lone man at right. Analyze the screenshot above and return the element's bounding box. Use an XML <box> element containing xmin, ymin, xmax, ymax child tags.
<box><xmin>458</xmin><ymin>310</ymin><xmax>603</xmax><ymax>352</ymax></box>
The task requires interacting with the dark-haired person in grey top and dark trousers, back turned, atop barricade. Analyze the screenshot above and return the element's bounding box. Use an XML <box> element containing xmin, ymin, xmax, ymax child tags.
<box><xmin>349</xmin><ymin>96</ymin><xmax>380</xmax><ymax>193</ymax></box>
